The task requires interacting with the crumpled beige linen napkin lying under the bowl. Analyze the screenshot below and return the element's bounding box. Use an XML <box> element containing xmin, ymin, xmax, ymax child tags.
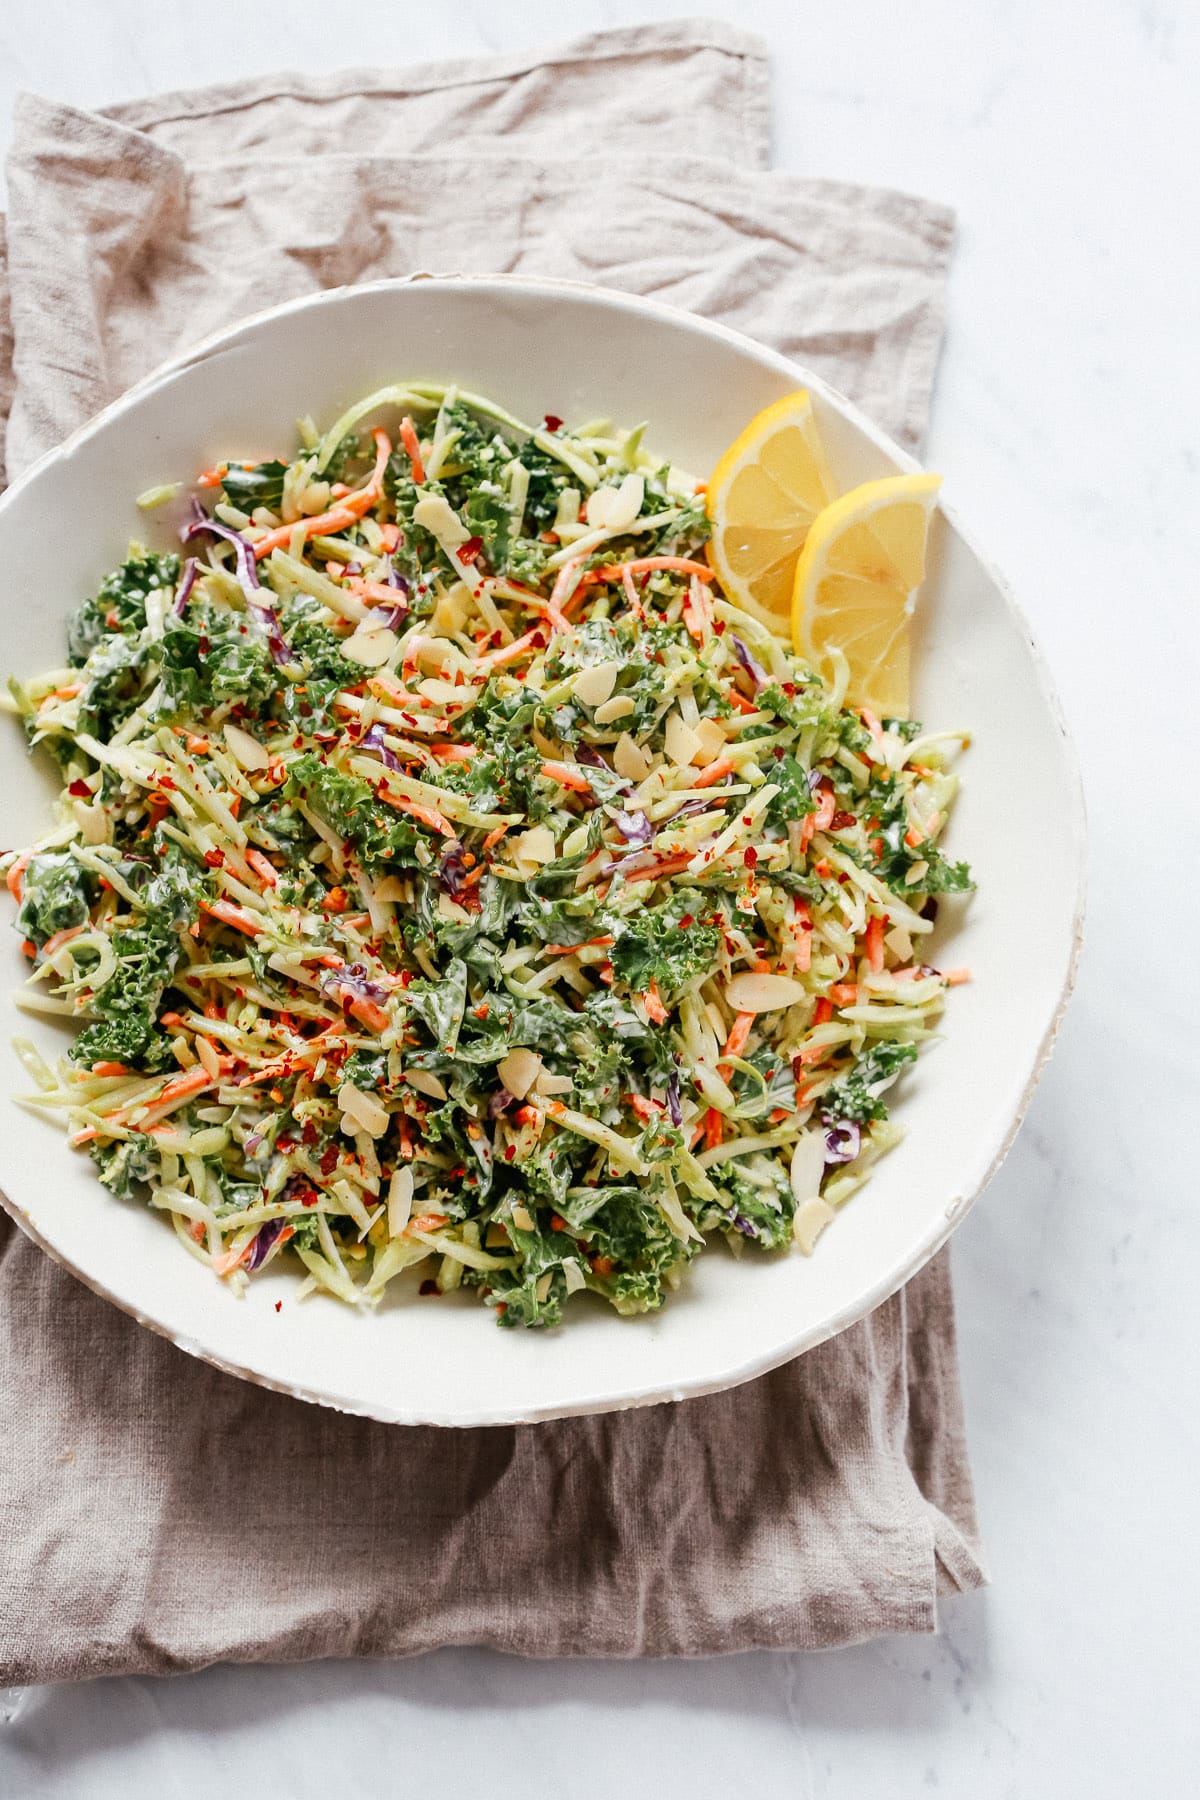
<box><xmin>0</xmin><ymin>22</ymin><xmax>984</xmax><ymax>1683</ymax></box>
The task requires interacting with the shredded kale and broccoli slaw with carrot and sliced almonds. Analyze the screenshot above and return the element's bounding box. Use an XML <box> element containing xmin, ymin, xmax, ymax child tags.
<box><xmin>0</xmin><ymin>383</ymin><xmax>970</xmax><ymax>1325</ymax></box>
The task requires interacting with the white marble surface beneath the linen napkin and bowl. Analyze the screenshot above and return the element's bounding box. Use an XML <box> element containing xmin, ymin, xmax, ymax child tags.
<box><xmin>0</xmin><ymin>0</ymin><xmax>1200</xmax><ymax>1800</ymax></box>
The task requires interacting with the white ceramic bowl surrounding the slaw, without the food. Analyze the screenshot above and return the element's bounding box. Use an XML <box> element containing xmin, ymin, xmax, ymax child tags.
<box><xmin>0</xmin><ymin>277</ymin><xmax>1083</xmax><ymax>1426</ymax></box>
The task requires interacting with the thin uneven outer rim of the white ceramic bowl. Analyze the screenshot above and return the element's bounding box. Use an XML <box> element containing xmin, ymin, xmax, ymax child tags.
<box><xmin>0</xmin><ymin>270</ymin><xmax>1087</xmax><ymax>1429</ymax></box>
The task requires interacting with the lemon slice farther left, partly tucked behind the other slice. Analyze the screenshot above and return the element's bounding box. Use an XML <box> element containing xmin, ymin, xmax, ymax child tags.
<box><xmin>707</xmin><ymin>389</ymin><xmax>833</xmax><ymax>635</ymax></box>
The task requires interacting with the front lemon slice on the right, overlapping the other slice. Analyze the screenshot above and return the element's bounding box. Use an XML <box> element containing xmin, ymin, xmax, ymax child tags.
<box><xmin>792</xmin><ymin>475</ymin><xmax>941</xmax><ymax>718</ymax></box>
